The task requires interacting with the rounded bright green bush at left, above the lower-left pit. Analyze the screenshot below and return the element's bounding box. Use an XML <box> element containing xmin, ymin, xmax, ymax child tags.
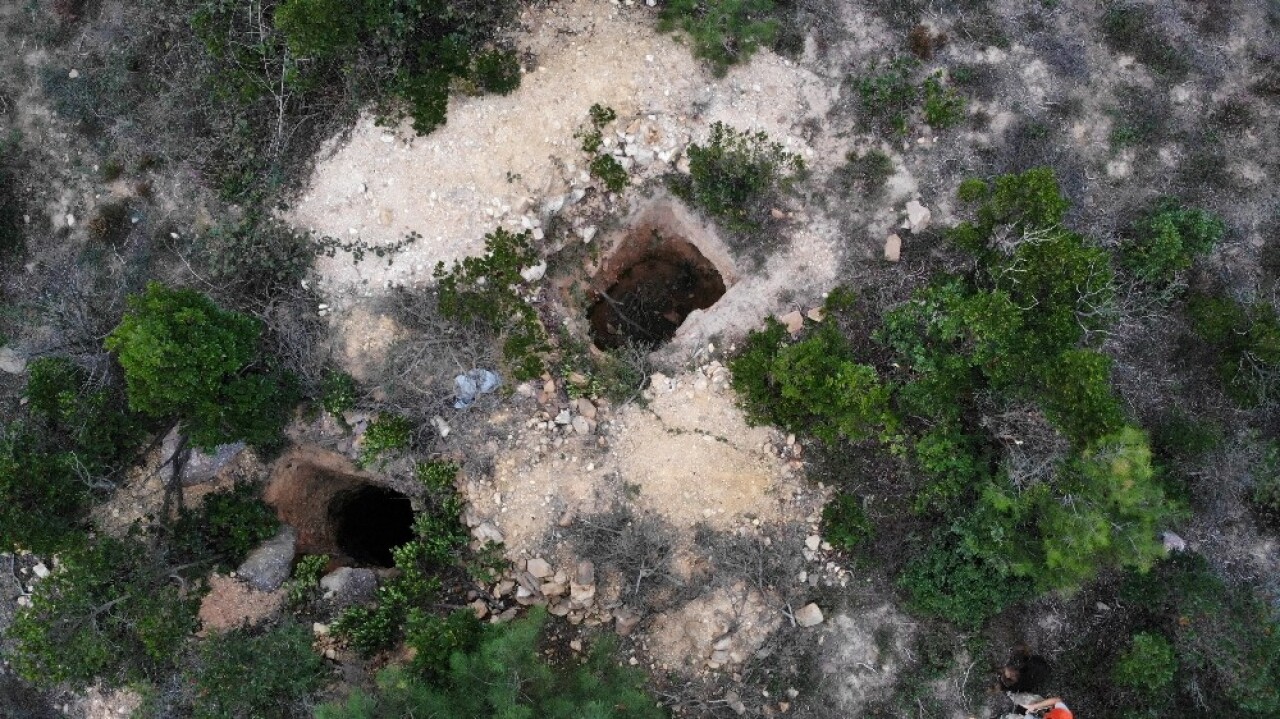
<box><xmin>104</xmin><ymin>283</ymin><xmax>297</xmax><ymax>449</ymax></box>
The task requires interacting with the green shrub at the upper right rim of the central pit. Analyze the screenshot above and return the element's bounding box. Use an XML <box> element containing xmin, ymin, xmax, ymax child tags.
<box><xmin>672</xmin><ymin>123</ymin><xmax>805</xmax><ymax>232</ymax></box>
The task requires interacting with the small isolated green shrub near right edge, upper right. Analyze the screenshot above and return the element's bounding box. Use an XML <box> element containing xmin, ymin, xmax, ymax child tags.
<box><xmin>1121</xmin><ymin>200</ymin><xmax>1226</xmax><ymax>289</ymax></box>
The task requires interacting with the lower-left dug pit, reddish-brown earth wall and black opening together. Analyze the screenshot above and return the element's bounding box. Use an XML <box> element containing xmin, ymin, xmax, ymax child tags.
<box><xmin>265</xmin><ymin>448</ymin><xmax>413</xmax><ymax>567</ymax></box>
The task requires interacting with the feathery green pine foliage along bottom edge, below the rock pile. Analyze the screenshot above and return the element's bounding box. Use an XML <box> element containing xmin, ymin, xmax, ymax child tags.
<box><xmin>316</xmin><ymin>609</ymin><xmax>666</xmax><ymax>719</ymax></box>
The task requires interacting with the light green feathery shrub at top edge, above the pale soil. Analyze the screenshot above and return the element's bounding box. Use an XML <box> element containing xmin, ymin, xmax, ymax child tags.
<box><xmin>658</xmin><ymin>0</ymin><xmax>780</xmax><ymax>77</ymax></box>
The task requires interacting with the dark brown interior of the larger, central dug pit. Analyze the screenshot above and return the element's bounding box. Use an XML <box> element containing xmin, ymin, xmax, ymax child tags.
<box><xmin>589</xmin><ymin>232</ymin><xmax>724</xmax><ymax>349</ymax></box>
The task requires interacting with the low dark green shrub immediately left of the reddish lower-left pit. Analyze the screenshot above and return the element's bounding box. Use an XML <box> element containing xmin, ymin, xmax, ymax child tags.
<box><xmin>172</xmin><ymin>482</ymin><xmax>280</xmax><ymax>567</ymax></box>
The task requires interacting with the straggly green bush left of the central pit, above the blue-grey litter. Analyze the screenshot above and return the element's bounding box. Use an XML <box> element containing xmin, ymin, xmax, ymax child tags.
<box><xmin>435</xmin><ymin>228</ymin><xmax>548</xmax><ymax>380</ymax></box>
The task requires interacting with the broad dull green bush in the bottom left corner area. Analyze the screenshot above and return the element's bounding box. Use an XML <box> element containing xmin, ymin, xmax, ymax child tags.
<box><xmin>8</xmin><ymin>537</ymin><xmax>198</xmax><ymax>687</ymax></box>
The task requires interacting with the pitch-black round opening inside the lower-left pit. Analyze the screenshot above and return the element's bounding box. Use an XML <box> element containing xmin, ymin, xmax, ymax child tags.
<box><xmin>329</xmin><ymin>486</ymin><xmax>413</xmax><ymax>567</ymax></box>
